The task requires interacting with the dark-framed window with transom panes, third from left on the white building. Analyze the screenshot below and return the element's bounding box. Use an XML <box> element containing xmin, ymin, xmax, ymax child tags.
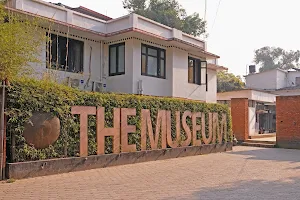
<box><xmin>141</xmin><ymin>44</ymin><xmax>166</xmax><ymax>78</ymax></box>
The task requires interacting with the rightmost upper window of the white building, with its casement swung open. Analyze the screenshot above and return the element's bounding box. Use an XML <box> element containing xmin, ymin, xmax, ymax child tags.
<box><xmin>188</xmin><ymin>57</ymin><xmax>208</xmax><ymax>86</ymax></box>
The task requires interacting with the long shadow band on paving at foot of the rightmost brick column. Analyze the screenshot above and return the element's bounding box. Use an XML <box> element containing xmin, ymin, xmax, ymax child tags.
<box><xmin>226</xmin><ymin>148</ymin><xmax>300</xmax><ymax>162</ymax></box>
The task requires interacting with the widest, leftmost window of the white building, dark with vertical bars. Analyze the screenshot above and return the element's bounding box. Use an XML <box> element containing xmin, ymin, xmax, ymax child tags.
<box><xmin>46</xmin><ymin>34</ymin><xmax>84</xmax><ymax>73</ymax></box>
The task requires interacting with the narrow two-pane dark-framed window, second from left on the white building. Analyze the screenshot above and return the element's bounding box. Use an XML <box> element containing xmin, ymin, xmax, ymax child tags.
<box><xmin>109</xmin><ymin>43</ymin><xmax>125</xmax><ymax>76</ymax></box>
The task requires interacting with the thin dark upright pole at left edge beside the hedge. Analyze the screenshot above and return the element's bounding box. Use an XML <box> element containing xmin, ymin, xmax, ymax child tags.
<box><xmin>0</xmin><ymin>81</ymin><xmax>6</xmax><ymax>180</ymax></box>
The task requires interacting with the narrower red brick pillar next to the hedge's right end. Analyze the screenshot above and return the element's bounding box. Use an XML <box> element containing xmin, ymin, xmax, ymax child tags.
<box><xmin>231</xmin><ymin>98</ymin><xmax>249</xmax><ymax>141</ymax></box>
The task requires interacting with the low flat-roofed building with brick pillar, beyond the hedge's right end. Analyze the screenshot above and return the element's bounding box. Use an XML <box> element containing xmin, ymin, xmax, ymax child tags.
<box><xmin>217</xmin><ymin>89</ymin><xmax>276</xmax><ymax>140</ymax></box>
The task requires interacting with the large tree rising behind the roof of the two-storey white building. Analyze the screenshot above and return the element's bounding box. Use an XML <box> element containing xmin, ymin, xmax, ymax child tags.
<box><xmin>123</xmin><ymin>0</ymin><xmax>206</xmax><ymax>36</ymax></box>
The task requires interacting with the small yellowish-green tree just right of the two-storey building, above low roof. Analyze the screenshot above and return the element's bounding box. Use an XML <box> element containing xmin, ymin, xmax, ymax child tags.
<box><xmin>217</xmin><ymin>72</ymin><xmax>245</xmax><ymax>92</ymax></box>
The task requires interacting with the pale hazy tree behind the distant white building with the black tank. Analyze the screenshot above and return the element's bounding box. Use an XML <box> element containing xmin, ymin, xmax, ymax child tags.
<box><xmin>254</xmin><ymin>46</ymin><xmax>300</xmax><ymax>72</ymax></box>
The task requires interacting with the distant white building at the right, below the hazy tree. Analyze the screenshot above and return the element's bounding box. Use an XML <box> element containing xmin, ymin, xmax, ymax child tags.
<box><xmin>245</xmin><ymin>69</ymin><xmax>300</xmax><ymax>96</ymax></box>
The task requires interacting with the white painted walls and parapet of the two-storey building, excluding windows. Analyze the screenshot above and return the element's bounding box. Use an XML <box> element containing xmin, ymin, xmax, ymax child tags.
<box><xmin>13</xmin><ymin>0</ymin><xmax>216</xmax><ymax>102</ymax></box>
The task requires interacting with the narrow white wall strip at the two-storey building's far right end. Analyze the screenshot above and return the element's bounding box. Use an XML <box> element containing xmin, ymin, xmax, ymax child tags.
<box><xmin>206</xmin><ymin>69</ymin><xmax>217</xmax><ymax>103</ymax></box>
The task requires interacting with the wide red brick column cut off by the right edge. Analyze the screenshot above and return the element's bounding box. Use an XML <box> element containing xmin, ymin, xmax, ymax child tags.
<box><xmin>276</xmin><ymin>96</ymin><xmax>300</xmax><ymax>149</ymax></box>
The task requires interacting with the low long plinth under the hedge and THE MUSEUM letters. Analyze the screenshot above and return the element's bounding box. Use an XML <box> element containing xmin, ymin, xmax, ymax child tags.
<box><xmin>7</xmin><ymin>142</ymin><xmax>232</xmax><ymax>179</ymax></box>
